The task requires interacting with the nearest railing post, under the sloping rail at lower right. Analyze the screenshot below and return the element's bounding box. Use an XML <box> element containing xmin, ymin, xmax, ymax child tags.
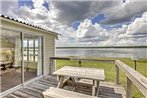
<box><xmin>126</xmin><ymin>77</ymin><xmax>132</xmax><ymax>98</ymax></box>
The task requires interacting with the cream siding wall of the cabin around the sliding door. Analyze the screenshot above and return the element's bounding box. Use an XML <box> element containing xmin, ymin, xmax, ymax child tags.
<box><xmin>0</xmin><ymin>19</ymin><xmax>57</xmax><ymax>75</ymax></box>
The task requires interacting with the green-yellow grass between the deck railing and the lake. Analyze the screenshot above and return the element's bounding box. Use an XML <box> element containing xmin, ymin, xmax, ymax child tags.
<box><xmin>56</xmin><ymin>58</ymin><xmax>147</xmax><ymax>98</ymax></box>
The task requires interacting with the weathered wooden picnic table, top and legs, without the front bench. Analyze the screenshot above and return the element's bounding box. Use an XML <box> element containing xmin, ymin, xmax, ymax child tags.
<box><xmin>53</xmin><ymin>66</ymin><xmax>105</xmax><ymax>96</ymax></box>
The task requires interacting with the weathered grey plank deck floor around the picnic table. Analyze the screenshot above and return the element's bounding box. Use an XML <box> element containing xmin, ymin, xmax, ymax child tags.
<box><xmin>4</xmin><ymin>76</ymin><xmax>126</xmax><ymax>98</ymax></box>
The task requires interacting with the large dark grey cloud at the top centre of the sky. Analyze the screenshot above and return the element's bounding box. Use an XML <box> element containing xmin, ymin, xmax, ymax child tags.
<box><xmin>50</xmin><ymin>0</ymin><xmax>120</xmax><ymax>26</ymax></box>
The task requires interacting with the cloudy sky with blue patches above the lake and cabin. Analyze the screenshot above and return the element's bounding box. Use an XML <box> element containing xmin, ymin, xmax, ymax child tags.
<box><xmin>0</xmin><ymin>0</ymin><xmax>147</xmax><ymax>47</ymax></box>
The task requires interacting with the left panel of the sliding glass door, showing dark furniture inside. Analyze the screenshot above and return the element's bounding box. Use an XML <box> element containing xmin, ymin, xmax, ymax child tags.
<box><xmin>0</xmin><ymin>29</ymin><xmax>22</xmax><ymax>92</ymax></box>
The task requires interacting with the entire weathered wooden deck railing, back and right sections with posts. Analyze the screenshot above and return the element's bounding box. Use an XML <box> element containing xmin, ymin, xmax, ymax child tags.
<box><xmin>49</xmin><ymin>57</ymin><xmax>147</xmax><ymax>98</ymax></box>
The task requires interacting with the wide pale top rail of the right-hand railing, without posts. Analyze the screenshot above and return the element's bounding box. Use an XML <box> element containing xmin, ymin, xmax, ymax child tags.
<box><xmin>115</xmin><ymin>60</ymin><xmax>147</xmax><ymax>97</ymax></box>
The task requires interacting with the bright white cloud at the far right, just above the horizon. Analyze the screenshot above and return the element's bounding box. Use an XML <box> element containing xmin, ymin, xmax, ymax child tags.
<box><xmin>107</xmin><ymin>12</ymin><xmax>147</xmax><ymax>46</ymax></box>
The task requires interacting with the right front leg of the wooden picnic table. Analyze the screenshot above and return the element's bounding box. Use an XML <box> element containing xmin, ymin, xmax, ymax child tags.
<box><xmin>92</xmin><ymin>80</ymin><xmax>99</xmax><ymax>96</ymax></box>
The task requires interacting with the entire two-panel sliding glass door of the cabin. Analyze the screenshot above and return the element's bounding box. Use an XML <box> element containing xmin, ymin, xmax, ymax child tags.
<box><xmin>0</xmin><ymin>29</ymin><xmax>43</xmax><ymax>93</ymax></box>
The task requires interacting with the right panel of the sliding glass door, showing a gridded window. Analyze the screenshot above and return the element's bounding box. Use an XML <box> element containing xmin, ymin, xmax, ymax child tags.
<box><xmin>23</xmin><ymin>33</ymin><xmax>42</xmax><ymax>81</ymax></box>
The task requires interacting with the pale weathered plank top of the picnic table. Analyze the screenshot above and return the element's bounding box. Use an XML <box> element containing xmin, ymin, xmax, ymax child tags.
<box><xmin>53</xmin><ymin>66</ymin><xmax>105</xmax><ymax>81</ymax></box>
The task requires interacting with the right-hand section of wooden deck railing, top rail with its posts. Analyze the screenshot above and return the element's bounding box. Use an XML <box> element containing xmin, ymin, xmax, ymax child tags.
<box><xmin>115</xmin><ymin>60</ymin><xmax>147</xmax><ymax>98</ymax></box>
